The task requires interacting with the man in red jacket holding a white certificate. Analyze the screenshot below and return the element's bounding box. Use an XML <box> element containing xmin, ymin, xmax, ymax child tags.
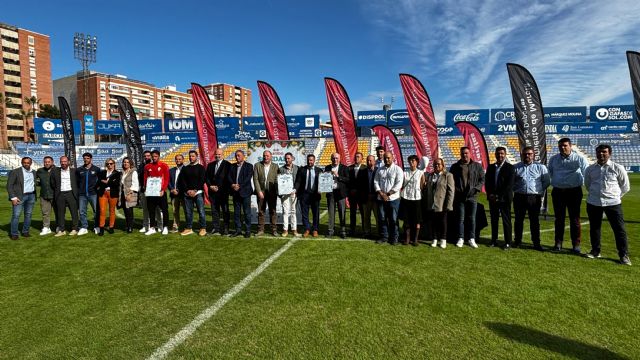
<box><xmin>144</xmin><ymin>150</ymin><xmax>169</xmax><ymax>235</ymax></box>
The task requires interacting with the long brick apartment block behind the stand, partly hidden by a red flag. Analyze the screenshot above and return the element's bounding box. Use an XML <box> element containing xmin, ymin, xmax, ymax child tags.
<box><xmin>53</xmin><ymin>71</ymin><xmax>251</xmax><ymax>120</ymax></box>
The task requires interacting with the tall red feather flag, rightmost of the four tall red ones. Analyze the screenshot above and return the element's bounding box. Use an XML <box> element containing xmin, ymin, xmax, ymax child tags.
<box><xmin>400</xmin><ymin>74</ymin><xmax>440</xmax><ymax>171</ymax></box>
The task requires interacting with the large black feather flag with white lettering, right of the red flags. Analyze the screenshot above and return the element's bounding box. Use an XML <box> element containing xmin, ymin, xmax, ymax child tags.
<box><xmin>507</xmin><ymin>63</ymin><xmax>547</xmax><ymax>165</ymax></box>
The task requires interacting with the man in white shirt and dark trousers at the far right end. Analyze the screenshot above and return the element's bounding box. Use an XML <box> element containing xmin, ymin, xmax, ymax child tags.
<box><xmin>584</xmin><ymin>144</ymin><xmax>631</xmax><ymax>265</ymax></box>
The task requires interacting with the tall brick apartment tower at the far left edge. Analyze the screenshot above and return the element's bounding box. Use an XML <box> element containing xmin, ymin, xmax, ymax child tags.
<box><xmin>0</xmin><ymin>23</ymin><xmax>53</xmax><ymax>148</ymax></box>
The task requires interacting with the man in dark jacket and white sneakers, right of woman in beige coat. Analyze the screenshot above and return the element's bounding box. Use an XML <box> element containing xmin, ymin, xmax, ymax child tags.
<box><xmin>449</xmin><ymin>146</ymin><xmax>484</xmax><ymax>248</ymax></box>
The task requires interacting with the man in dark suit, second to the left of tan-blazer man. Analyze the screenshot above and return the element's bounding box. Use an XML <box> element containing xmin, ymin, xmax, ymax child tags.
<box><xmin>205</xmin><ymin>149</ymin><xmax>231</xmax><ymax>235</ymax></box>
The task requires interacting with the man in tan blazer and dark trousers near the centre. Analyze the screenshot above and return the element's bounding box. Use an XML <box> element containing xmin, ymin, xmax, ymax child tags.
<box><xmin>253</xmin><ymin>150</ymin><xmax>278</xmax><ymax>236</ymax></box>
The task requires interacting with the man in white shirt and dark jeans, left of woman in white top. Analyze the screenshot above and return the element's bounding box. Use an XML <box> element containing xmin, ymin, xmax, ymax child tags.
<box><xmin>373</xmin><ymin>151</ymin><xmax>404</xmax><ymax>245</ymax></box>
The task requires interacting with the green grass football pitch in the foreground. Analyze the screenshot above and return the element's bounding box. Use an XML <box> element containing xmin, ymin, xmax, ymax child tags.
<box><xmin>0</xmin><ymin>176</ymin><xmax>640</xmax><ymax>359</ymax></box>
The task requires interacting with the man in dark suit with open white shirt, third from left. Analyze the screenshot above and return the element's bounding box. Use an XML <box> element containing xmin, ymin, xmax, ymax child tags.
<box><xmin>50</xmin><ymin>156</ymin><xmax>78</xmax><ymax>236</ymax></box>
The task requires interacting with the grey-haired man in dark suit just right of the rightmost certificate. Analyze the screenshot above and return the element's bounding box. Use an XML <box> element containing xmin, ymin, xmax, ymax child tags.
<box><xmin>324</xmin><ymin>153</ymin><xmax>349</xmax><ymax>239</ymax></box>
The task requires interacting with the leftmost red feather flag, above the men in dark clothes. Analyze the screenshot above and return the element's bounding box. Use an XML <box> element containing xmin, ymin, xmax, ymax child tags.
<box><xmin>191</xmin><ymin>83</ymin><xmax>218</xmax><ymax>165</ymax></box>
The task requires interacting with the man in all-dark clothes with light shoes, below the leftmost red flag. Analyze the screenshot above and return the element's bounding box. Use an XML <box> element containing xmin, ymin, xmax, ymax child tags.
<box><xmin>178</xmin><ymin>150</ymin><xmax>207</xmax><ymax>236</ymax></box>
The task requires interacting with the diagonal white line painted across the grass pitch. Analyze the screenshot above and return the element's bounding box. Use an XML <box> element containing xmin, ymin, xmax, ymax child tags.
<box><xmin>147</xmin><ymin>239</ymin><xmax>298</xmax><ymax>360</ymax></box>
